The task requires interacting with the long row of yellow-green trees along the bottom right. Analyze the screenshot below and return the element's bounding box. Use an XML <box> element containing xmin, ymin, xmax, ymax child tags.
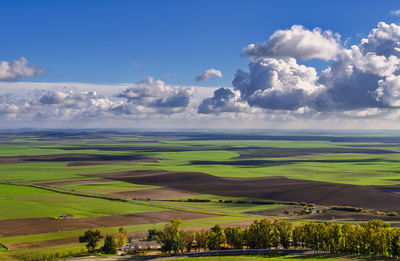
<box><xmin>153</xmin><ymin>218</ymin><xmax>400</xmax><ymax>257</ymax></box>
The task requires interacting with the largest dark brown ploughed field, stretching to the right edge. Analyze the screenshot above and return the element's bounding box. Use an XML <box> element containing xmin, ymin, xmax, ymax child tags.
<box><xmin>97</xmin><ymin>171</ymin><xmax>400</xmax><ymax>211</ymax></box>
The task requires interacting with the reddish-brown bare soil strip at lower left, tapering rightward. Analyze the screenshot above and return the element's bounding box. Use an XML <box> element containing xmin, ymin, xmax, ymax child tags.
<box><xmin>0</xmin><ymin>210</ymin><xmax>217</xmax><ymax>237</ymax></box>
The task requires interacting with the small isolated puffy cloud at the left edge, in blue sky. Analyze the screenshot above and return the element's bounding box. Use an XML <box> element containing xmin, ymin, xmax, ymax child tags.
<box><xmin>0</xmin><ymin>57</ymin><xmax>47</xmax><ymax>81</ymax></box>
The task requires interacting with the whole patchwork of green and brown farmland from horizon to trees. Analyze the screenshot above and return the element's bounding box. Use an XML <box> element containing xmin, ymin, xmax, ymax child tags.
<box><xmin>0</xmin><ymin>131</ymin><xmax>400</xmax><ymax>260</ymax></box>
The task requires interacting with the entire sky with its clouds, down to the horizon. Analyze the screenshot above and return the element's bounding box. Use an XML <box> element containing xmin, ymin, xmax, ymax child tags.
<box><xmin>0</xmin><ymin>0</ymin><xmax>400</xmax><ymax>129</ymax></box>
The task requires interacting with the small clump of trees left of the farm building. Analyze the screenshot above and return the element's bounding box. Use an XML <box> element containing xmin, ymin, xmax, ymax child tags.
<box><xmin>79</xmin><ymin>224</ymin><xmax>127</xmax><ymax>254</ymax></box>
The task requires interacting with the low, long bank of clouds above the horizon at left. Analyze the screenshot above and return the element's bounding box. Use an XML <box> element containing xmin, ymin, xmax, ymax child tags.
<box><xmin>0</xmin><ymin>77</ymin><xmax>194</xmax><ymax>120</ymax></box>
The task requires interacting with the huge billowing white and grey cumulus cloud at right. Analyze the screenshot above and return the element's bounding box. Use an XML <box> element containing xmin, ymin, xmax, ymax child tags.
<box><xmin>203</xmin><ymin>22</ymin><xmax>400</xmax><ymax>113</ymax></box>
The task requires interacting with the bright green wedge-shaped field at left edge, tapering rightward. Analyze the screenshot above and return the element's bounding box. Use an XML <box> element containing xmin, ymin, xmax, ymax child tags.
<box><xmin>0</xmin><ymin>184</ymin><xmax>164</xmax><ymax>220</ymax></box>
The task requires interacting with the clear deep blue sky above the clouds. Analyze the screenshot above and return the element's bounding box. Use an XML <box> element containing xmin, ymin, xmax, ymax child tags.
<box><xmin>0</xmin><ymin>0</ymin><xmax>400</xmax><ymax>86</ymax></box>
